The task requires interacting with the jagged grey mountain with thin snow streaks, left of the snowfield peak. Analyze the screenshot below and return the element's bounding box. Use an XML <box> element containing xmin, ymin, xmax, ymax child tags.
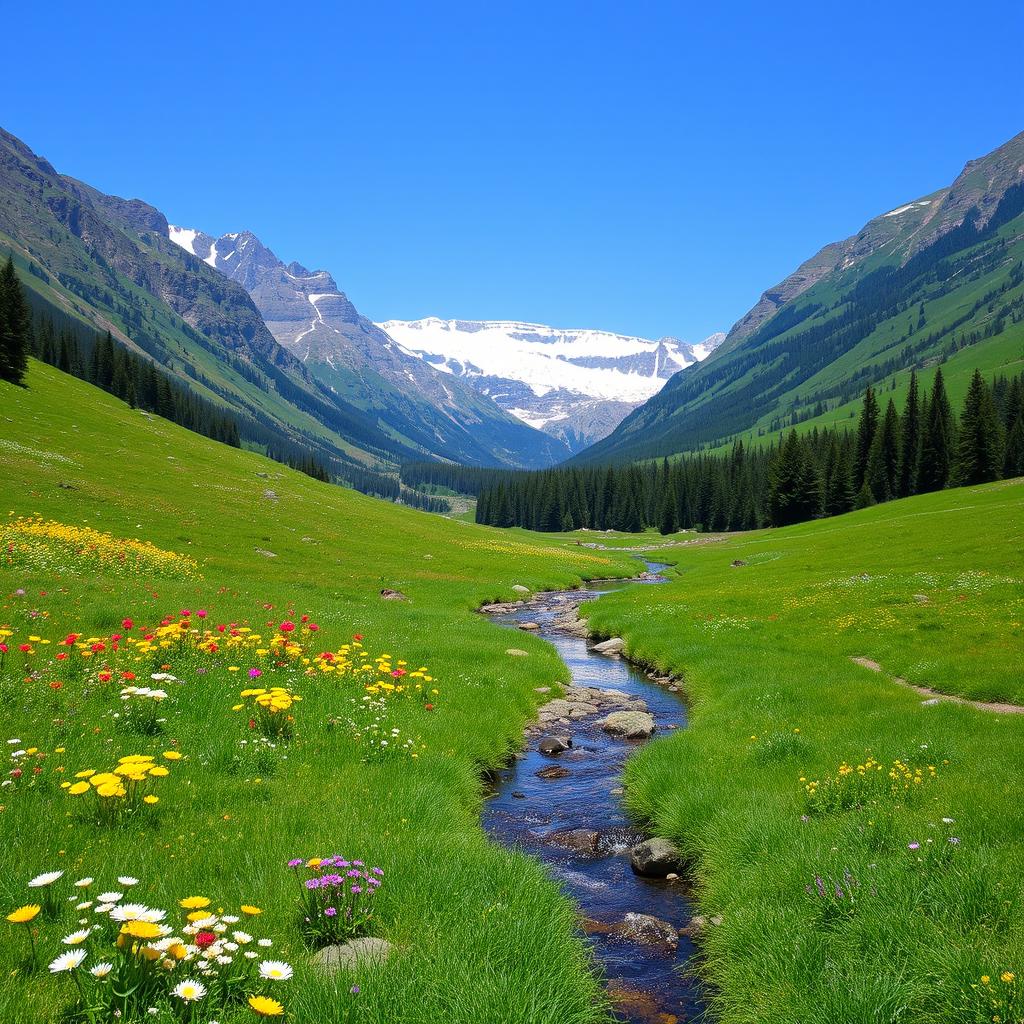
<box><xmin>167</xmin><ymin>225</ymin><xmax>569</xmax><ymax>467</ymax></box>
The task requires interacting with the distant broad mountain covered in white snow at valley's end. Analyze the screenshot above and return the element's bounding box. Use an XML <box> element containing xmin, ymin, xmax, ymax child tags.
<box><xmin>377</xmin><ymin>316</ymin><xmax>725</xmax><ymax>452</ymax></box>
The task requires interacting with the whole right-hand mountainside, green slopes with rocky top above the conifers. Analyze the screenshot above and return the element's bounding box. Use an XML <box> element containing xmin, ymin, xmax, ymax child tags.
<box><xmin>577</xmin><ymin>126</ymin><xmax>1024</xmax><ymax>463</ymax></box>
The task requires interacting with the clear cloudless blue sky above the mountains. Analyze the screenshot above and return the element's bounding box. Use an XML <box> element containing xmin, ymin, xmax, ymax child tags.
<box><xmin>0</xmin><ymin>0</ymin><xmax>1024</xmax><ymax>340</ymax></box>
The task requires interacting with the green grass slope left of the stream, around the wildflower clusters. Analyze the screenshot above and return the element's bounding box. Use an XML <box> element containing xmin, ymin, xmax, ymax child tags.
<box><xmin>0</xmin><ymin>362</ymin><xmax>635</xmax><ymax>1024</ymax></box>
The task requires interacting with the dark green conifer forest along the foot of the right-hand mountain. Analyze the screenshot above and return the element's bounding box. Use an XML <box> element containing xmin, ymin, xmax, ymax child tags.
<box><xmin>471</xmin><ymin>369</ymin><xmax>1024</xmax><ymax>534</ymax></box>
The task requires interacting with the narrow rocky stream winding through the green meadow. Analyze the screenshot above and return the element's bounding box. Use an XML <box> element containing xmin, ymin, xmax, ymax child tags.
<box><xmin>483</xmin><ymin>562</ymin><xmax>703</xmax><ymax>1024</ymax></box>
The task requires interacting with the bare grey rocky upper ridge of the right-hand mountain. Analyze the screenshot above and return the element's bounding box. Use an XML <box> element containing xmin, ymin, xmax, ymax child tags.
<box><xmin>722</xmin><ymin>132</ymin><xmax>1024</xmax><ymax>354</ymax></box>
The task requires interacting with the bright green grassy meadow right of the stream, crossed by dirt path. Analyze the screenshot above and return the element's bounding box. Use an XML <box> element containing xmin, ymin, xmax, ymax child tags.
<box><xmin>590</xmin><ymin>480</ymin><xmax>1024</xmax><ymax>1024</ymax></box>
